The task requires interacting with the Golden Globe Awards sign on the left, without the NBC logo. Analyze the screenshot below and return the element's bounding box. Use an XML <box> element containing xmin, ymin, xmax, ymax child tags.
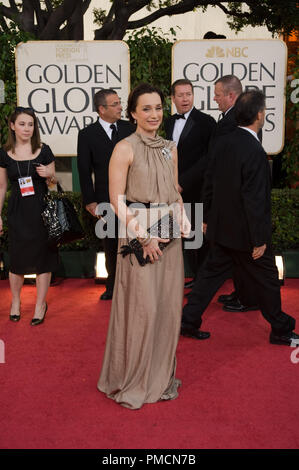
<box><xmin>16</xmin><ymin>41</ymin><xmax>130</xmax><ymax>156</ymax></box>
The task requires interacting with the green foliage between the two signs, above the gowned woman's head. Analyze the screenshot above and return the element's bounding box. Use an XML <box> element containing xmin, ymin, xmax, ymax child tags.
<box><xmin>126</xmin><ymin>27</ymin><xmax>176</xmax><ymax>120</ymax></box>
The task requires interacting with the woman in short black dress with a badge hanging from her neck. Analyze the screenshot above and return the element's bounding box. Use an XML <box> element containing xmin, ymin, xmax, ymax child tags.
<box><xmin>0</xmin><ymin>107</ymin><xmax>58</xmax><ymax>326</ymax></box>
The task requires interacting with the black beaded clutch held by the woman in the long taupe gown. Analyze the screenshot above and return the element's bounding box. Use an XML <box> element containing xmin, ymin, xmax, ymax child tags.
<box><xmin>120</xmin><ymin>214</ymin><xmax>181</xmax><ymax>266</ymax></box>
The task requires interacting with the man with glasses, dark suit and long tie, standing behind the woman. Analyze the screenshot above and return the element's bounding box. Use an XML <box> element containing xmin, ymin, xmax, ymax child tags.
<box><xmin>77</xmin><ymin>89</ymin><xmax>135</xmax><ymax>300</ymax></box>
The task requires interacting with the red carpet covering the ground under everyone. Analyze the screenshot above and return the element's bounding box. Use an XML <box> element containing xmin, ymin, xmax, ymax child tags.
<box><xmin>0</xmin><ymin>279</ymin><xmax>299</xmax><ymax>449</ymax></box>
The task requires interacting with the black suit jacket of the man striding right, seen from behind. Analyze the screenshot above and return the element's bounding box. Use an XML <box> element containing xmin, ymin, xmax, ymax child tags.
<box><xmin>207</xmin><ymin>128</ymin><xmax>271</xmax><ymax>251</ymax></box>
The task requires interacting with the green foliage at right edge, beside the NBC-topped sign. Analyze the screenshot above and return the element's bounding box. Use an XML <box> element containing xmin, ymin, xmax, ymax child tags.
<box><xmin>282</xmin><ymin>55</ymin><xmax>299</xmax><ymax>185</ymax></box>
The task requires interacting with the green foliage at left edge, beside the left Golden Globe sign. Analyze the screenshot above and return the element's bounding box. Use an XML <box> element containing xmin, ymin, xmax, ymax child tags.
<box><xmin>0</xmin><ymin>23</ymin><xmax>34</xmax><ymax>146</ymax></box>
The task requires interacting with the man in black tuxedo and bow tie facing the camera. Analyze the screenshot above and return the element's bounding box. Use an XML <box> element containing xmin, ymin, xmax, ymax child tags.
<box><xmin>165</xmin><ymin>79</ymin><xmax>216</xmax><ymax>330</ymax></box>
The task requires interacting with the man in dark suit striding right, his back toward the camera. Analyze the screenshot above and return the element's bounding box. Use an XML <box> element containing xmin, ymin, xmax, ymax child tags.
<box><xmin>185</xmin><ymin>90</ymin><xmax>299</xmax><ymax>345</ymax></box>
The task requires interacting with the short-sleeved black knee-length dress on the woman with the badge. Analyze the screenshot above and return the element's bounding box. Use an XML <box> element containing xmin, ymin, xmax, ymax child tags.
<box><xmin>0</xmin><ymin>144</ymin><xmax>58</xmax><ymax>274</ymax></box>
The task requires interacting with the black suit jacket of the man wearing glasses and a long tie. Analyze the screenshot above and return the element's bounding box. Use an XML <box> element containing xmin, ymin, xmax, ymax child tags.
<box><xmin>77</xmin><ymin>120</ymin><xmax>135</xmax><ymax>205</ymax></box>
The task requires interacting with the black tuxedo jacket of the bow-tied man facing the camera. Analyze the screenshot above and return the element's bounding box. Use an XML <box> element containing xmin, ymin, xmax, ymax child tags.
<box><xmin>165</xmin><ymin>108</ymin><xmax>216</xmax><ymax>202</ymax></box>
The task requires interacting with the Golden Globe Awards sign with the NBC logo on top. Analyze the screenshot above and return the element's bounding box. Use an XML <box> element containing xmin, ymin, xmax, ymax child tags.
<box><xmin>172</xmin><ymin>39</ymin><xmax>287</xmax><ymax>154</ymax></box>
